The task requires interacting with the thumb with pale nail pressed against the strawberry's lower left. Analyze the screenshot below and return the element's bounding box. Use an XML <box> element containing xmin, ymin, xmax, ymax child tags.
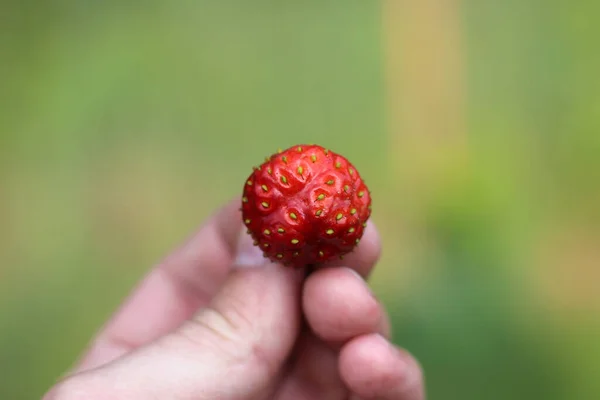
<box><xmin>47</xmin><ymin>239</ymin><xmax>303</xmax><ymax>400</ymax></box>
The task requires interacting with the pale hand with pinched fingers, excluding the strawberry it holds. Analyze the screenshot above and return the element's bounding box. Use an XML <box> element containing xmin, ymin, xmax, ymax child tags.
<box><xmin>44</xmin><ymin>200</ymin><xmax>425</xmax><ymax>400</ymax></box>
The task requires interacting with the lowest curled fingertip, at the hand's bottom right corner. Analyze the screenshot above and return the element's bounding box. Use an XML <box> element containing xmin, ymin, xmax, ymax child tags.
<box><xmin>339</xmin><ymin>334</ymin><xmax>425</xmax><ymax>400</ymax></box>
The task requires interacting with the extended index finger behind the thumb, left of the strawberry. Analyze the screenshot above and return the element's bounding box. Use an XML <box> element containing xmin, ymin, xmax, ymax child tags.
<box><xmin>76</xmin><ymin>200</ymin><xmax>242</xmax><ymax>371</ymax></box>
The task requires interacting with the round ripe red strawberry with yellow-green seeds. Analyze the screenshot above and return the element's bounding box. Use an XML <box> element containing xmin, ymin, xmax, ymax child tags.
<box><xmin>242</xmin><ymin>145</ymin><xmax>371</xmax><ymax>267</ymax></box>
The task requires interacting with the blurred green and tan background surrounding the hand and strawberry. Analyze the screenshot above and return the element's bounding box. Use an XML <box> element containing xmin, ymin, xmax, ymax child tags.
<box><xmin>0</xmin><ymin>0</ymin><xmax>600</xmax><ymax>400</ymax></box>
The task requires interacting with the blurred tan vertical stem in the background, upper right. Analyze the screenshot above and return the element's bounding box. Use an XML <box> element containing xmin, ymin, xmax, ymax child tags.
<box><xmin>383</xmin><ymin>0</ymin><xmax>467</xmax><ymax>220</ymax></box>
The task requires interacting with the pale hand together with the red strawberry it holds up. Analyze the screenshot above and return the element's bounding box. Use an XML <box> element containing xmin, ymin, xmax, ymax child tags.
<box><xmin>44</xmin><ymin>147</ymin><xmax>424</xmax><ymax>400</ymax></box>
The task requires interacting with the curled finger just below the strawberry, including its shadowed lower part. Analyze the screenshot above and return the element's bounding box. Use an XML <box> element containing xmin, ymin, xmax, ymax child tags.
<box><xmin>278</xmin><ymin>265</ymin><xmax>390</xmax><ymax>399</ymax></box>
